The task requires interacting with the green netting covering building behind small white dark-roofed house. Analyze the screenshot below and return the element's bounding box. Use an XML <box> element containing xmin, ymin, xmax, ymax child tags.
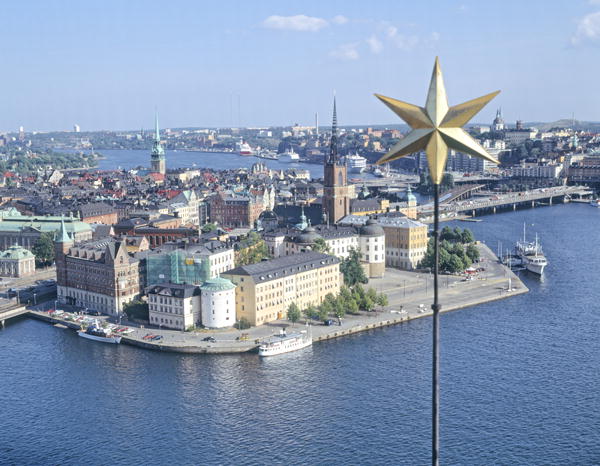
<box><xmin>146</xmin><ymin>250</ymin><xmax>210</xmax><ymax>286</ymax></box>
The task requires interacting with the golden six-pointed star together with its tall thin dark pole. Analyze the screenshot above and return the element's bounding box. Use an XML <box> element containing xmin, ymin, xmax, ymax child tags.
<box><xmin>375</xmin><ymin>58</ymin><xmax>500</xmax><ymax>465</ymax></box>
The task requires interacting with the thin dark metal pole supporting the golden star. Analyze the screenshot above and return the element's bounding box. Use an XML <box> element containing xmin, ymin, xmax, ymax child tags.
<box><xmin>431</xmin><ymin>184</ymin><xmax>441</xmax><ymax>466</ymax></box>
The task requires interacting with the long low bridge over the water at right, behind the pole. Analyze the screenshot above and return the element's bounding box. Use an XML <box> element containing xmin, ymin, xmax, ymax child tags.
<box><xmin>419</xmin><ymin>186</ymin><xmax>593</xmax><ymax>217</ymax></box>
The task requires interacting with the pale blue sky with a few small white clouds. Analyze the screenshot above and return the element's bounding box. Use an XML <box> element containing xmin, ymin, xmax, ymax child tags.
<box><xmin>0</xmin><ymin>0</ymin><xmax>600</xmax><ymax>131</ymax></box>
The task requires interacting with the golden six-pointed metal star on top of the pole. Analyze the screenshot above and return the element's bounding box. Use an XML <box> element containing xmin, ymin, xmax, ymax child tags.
<box><xmin>375</xmin><ymin>57</ymin><xmax>500</xmax><ymax>184</ymax></box>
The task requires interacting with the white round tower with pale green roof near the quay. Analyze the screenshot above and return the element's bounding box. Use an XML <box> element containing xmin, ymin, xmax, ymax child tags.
<box><xmin>200</xmin><ymin>278</ymin><xmax>236</xmax><ymax>328</ymax></box>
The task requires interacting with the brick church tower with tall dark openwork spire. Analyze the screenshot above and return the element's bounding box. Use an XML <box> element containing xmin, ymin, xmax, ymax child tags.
<box><xmin>323</xmin><ymin>97</ymin><xmax>350</xmax><ymax>223</ymax></box>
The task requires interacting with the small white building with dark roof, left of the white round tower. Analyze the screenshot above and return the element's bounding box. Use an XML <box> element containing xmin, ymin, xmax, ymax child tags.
<box><xmin>146</xmin><ymin>283</ymin><xmax>202</xmax><ymax>331</ymax></box>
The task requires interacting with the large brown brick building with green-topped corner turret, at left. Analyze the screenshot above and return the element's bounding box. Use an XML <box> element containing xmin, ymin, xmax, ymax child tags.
<box><xmin>55</xmin><ymin>222</ymin><xmax>140</xmax><ymax>316</ymax></box>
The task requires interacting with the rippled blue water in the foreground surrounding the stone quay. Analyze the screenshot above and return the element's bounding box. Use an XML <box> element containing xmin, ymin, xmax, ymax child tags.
<box><xmin>0</xmin><ymin>204</ymin><xmax>600</xmax><ymax>465</ymax></box>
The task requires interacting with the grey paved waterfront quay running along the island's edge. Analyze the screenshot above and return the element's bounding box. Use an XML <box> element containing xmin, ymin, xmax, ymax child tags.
<box><xmin>18</xmin><ymin>243</ymin><xmax>529</xmax><ymax>354</ymax></box>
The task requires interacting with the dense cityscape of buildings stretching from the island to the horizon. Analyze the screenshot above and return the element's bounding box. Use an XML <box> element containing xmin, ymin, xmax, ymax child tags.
<box><xmin>0</xmin><ymin>101</ymin><xmax>600</xmax><ymax>342</ymax></box>
